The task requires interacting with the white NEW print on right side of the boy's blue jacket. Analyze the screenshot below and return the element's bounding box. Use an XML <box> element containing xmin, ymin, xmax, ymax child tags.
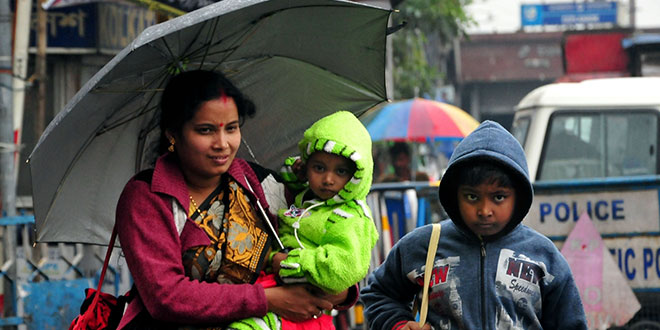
<box><xmin>495</xmin><ymin>249</ymin><xmax>554</xmax><ymax>329</ymax></box>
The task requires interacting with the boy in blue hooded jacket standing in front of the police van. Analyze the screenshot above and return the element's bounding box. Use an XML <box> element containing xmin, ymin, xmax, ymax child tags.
<box><xmin>361</xmin><ymin>121</ymin><xmax>587</xmax><ymax>329</ymax></box>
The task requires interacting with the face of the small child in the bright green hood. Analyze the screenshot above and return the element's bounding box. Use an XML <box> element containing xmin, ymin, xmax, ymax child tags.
<box><xmin>305</xmin><ymin>151</ymin><xmax>355</xmax><ymax>200</ymax></box>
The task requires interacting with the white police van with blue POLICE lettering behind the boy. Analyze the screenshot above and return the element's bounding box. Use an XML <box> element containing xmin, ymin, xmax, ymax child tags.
<box><xmin>511</xmin><ymin>77</ymin><xmax>660</xmax><ymax>322</ymax></box>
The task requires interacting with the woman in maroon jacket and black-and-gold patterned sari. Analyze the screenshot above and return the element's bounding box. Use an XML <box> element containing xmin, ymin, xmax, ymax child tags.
<box><xmin>116</xmin><ymin>70</ymin><xmax>350</xmax><ymax>329</ymax></box>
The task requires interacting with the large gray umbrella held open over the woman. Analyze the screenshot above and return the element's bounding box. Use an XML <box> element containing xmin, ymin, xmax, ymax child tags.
<box><xmin>29</xmin><ymin>0</ymin><xmax>391</xmax><ymax>244</ymax></box>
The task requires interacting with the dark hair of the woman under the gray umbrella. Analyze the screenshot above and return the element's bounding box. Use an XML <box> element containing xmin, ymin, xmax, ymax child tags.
<box><xmin>158</xmin><ymin>70</ymin><xmax>256</xmax><ymax>154</ymax></box>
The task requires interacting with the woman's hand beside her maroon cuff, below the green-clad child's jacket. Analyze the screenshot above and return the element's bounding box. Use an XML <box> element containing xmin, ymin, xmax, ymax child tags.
<box><xmin>265</xmin><ymin>285</ymin><xmax>333</xmax><ymax>322</ymax></box>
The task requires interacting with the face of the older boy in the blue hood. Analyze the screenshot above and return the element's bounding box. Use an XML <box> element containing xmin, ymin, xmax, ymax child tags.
<box><xmin>458</xmin><ymin>183</ymin><xmax>516</xmax><ymax>237</ymax></box>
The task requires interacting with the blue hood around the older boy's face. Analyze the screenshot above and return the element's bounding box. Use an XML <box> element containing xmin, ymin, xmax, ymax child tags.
<box><xmin>439</xmin><ymin>120</ymin><xmax>534</xmax><ymax>237</ymax></box>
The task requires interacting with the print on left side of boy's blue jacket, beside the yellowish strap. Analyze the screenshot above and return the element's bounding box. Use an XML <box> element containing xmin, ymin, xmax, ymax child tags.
<box><xmin>407</xmin><ymin>257</ymin><xmax>464</xmax><ymax>330</ymax></box>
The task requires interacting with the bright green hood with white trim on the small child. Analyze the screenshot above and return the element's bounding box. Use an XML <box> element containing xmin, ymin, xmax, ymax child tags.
<box><xmin>298</xmin><ymin>111</ymin><xmax>374</xmax><ymax>205</ymax></box>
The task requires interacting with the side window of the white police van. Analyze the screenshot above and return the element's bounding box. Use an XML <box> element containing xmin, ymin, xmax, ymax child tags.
<box><xmin>538</xmin><ymin>111</ymin><xmax>658</xmax><ymax>180</ymax></box>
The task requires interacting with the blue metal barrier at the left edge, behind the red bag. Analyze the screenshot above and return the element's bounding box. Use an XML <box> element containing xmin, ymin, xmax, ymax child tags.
<box><xmin>0</xmin><ymin>215</ymin><xmax>131</xmax><ymax>329</ymax></box>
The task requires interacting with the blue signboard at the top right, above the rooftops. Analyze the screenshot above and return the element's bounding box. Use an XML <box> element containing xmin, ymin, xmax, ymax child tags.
<box><xmin>520</xmin><ymin>2</ymin><xmax>617</xmax><ymax>26</ymax></box>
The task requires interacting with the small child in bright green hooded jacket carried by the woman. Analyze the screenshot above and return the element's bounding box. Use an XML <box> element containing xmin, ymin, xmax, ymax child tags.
<box><xmin>229</xmin><ymin>111</ymin><xmax>378</xmax><ymax>329</ymax></box>
